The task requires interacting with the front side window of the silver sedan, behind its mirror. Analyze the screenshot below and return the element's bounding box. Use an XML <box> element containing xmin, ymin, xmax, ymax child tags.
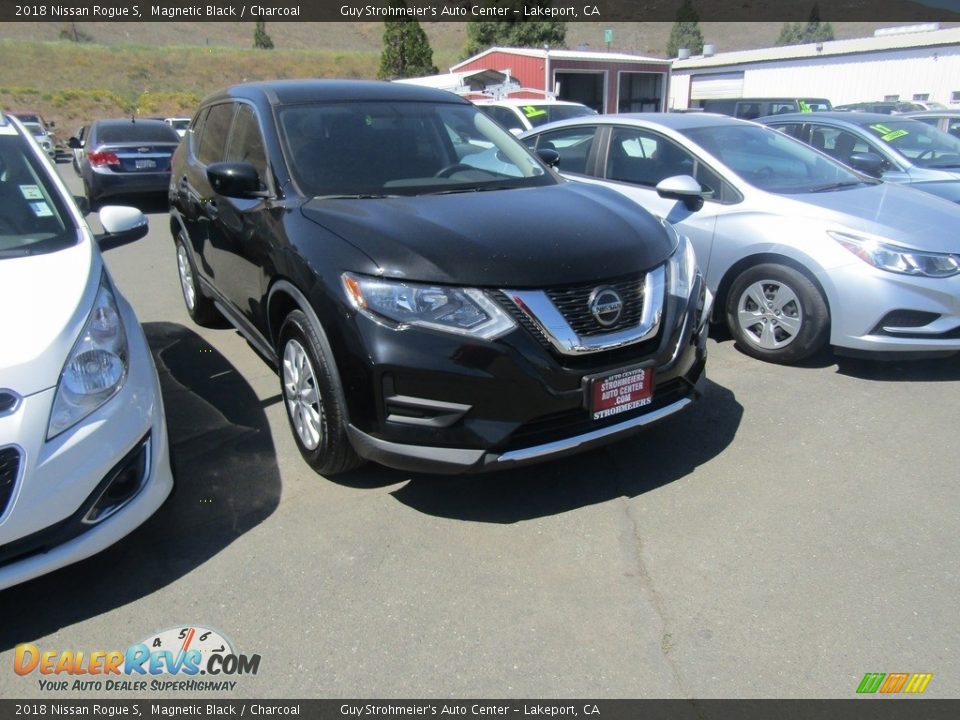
<box><xmin>608</xmin><ymin>128</ymin><xmax>695</xmax><ymax>187</ymax></box>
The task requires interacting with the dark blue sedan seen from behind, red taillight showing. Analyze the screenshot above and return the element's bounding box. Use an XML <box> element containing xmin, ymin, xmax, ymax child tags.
<box><xmin>70</xmin><ymin>118</ymin><xmax>180</xmax><ymax>209</ymax></box>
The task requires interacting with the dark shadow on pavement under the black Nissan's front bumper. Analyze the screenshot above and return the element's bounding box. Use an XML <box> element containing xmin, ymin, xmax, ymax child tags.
<box><xmin>333</xmin><ymin>381</ymin><xmax>743</xmax><ymax>523</ymax></box>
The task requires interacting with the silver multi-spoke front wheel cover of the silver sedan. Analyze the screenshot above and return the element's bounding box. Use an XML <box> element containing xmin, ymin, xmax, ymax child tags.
<box><xmin>737</xmin><ymin>280</ymin><xmax>803</xmax><ymax>350</ymax></box>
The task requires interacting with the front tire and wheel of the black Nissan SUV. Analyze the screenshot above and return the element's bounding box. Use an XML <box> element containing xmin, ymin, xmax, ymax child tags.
<box><xmin>277</xmin><ymin>310</ymin><xmax>363</xmax><ymax>476</ymax></box>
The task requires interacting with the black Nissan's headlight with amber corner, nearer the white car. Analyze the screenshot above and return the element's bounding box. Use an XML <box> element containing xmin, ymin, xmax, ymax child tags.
<box><xmin>341</xmin><ymin>273</ymin><xmax>516</xmax><ymax>340</ymax></box>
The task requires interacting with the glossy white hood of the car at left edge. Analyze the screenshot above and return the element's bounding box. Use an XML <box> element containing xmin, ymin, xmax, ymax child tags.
<box><xmin>0</xmin><ymin>234</ymin><xmax>103</xmax><ymax>397</ymax></box>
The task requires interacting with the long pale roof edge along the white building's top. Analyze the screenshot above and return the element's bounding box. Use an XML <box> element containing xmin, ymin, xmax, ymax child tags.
<box><xmin>672</xmin><ymin>28</ymin><xmax>960</xmax><ymax>72</ymax></box>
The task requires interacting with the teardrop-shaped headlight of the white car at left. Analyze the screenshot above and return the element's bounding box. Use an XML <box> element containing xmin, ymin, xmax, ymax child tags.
<box><xmin>47</xmin><ymin>275</ymin><xmax>129</xmax><ymax>440</ymax></box>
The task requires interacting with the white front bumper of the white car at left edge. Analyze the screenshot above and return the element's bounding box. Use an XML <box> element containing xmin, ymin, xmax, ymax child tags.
<box><xmin>0</xmin><ymin>296</ymin><xmax>173</xmax><ymax>590</ymax></box>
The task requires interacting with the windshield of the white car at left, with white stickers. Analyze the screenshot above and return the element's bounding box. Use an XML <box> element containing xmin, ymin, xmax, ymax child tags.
<box><xmin>0</xmin><ymin>135</ymin><xmax>78</xmax><ymax>255</ymax></box>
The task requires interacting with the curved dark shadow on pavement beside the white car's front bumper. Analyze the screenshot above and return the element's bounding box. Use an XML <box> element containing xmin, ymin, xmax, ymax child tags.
<box><xmin>0</xmin><ymin>322</ymin><xmax>280</xmax><ymax>650</ymax></box>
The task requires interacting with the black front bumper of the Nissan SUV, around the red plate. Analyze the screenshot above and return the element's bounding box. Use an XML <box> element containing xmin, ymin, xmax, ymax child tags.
<box><xmin>341</xmin><ymin>281</ymin><xmax>713</xmax><ymax>474</ymax></box>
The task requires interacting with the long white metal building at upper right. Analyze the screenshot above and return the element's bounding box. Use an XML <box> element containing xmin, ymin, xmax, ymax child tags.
<box><xmin>669</xmin><ymin>24</ymin><xmax>960</xmax><ymax>110</ymax></box>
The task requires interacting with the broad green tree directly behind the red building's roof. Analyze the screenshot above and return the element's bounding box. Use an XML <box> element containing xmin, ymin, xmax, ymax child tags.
<box><xmin>463</xmin><ymin>0</ymin><xmax>567</xmax><ymax>57</ymax></box>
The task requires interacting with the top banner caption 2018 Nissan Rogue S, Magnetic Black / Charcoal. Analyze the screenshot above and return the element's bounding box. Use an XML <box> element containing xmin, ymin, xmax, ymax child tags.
<box><xmin>14</xmin><ymin>3</ymin><xmax>302</xmax><ymax>20</ymax></box>
